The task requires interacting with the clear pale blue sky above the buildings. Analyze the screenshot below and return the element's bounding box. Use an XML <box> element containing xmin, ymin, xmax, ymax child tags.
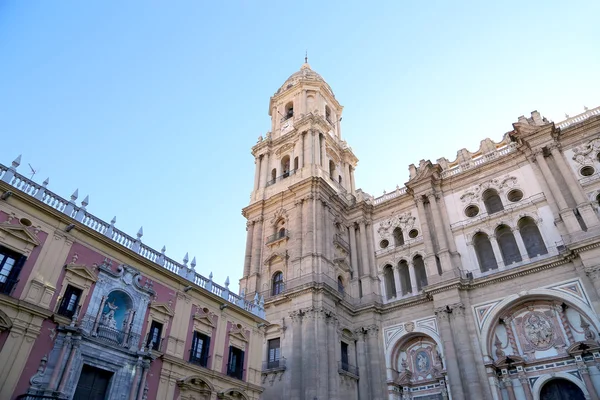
<box><xmin>0</xmin><ymin>0</ymin><xmax>600</xmax><ymax>291</ymax></box>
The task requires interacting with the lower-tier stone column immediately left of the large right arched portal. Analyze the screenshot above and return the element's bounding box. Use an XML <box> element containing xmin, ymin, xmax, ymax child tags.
<box><xmin>449</xmin><ymin>303</ymin><xmax>484</xmax><ymax>399</ymax></box>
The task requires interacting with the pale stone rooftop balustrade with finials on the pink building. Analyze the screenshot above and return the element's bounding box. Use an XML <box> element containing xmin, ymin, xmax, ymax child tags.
<box><xmin>0</xmin><ymin>156</ymin><xmax>265</xmax><ymax>318</ymax></box>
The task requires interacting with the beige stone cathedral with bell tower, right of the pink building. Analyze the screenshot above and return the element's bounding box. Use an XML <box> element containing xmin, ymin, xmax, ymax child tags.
<box><xmin>240</xmin><ymin>63</ymin><xmax>600</xmax><ymax>400</ymax></box>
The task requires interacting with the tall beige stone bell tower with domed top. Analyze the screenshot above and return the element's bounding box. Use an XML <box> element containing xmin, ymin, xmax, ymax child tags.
<box><xmin>240</xmin><ymin>62</ymin><xmax>385</xmax><ymax>400</ymax></box>
